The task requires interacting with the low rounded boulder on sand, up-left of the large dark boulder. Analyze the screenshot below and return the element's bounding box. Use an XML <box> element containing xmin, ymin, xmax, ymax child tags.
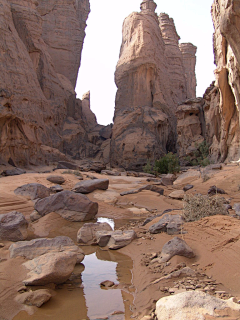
<box><xmin>14</xmin><ymin>183</ymin><xmax>50</xmax><ymax>200</ymax></box>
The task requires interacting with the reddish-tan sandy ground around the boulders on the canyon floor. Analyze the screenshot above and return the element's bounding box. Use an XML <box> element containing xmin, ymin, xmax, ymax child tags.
<box><xmin>0</xmin><ymin>164</ymin><xmax>240</xmax><ymax>320</ymax></box>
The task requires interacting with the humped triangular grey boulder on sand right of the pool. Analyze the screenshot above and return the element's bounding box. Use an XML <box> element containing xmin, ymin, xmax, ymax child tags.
<box><xmin>159</xmin><ymin>237</ymin><xmax>195</xmax><ymax>262</ymax></box>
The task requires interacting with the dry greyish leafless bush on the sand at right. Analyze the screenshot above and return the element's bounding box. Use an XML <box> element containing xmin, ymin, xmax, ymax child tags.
<box><xmin>182</xmin><ymin>194</ymin><xmax>228</xmax><ymax>222</ymax></box>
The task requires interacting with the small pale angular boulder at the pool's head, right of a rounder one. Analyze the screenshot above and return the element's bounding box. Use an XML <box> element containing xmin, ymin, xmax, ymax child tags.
<box><xmin>108</xmin><ymin>230</ymin><xmax>137</xmax><ymax>250</ymax></box>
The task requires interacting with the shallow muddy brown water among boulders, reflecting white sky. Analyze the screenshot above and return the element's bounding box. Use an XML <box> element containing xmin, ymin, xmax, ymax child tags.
<box><xmin>14</xmin><ymin>214</ymin><xmax>134</xmax><ymax>320</ymax></box>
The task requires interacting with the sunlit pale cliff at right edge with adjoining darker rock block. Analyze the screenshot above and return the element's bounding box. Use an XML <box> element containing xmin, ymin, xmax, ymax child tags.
<box><xmin>177</xmin><ymin>0</ymin><xmax>240</xmax><ymax>162</ymax></box>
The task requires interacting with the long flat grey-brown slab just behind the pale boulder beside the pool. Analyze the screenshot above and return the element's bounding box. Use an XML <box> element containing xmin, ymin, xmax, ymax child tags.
<box><xmin>9</xmin><ymin>236</ymin><xmax>84</xmax><ymax>263</ymax></box>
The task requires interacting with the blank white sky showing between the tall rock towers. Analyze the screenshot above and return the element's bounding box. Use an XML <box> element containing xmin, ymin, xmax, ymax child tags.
<box><xmin>76</xmin><ymin>0</ymin><xmax>215</xmax><ymax>125</ymax></box>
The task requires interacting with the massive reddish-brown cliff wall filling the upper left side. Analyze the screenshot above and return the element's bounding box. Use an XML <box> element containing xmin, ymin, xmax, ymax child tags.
<box><xmin>0</xmin><ymin>0</ymin><xmax>110</xmax><ymax>166</ymax></box>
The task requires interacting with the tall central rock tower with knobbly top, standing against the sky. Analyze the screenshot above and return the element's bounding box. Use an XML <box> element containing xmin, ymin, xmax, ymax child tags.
<box><xmin>110</xmin><ymin>0</ymin><xmax>196</xmax><ymax>170</ymax></box>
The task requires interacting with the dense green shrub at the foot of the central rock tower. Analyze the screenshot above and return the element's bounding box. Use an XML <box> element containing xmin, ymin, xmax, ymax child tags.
<box><xmin>153</xmin><ymin>152</ymin><xmax>180</xmax><ymax>174</ymax></box>
